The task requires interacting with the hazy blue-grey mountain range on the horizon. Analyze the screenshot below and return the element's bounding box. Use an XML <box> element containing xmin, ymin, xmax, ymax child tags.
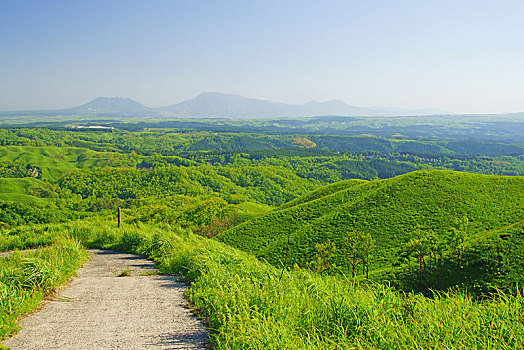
<box><xmin>0</xmin><ymin>92</ymin><xmax>449</xmax><ymax>119</ymax></box>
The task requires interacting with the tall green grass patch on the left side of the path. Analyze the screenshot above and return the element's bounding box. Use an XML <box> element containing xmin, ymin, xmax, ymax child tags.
<box><xmin>0</xmin><ymin>238</ymin><xmax>87</xmax><ymax>339</ymax></box>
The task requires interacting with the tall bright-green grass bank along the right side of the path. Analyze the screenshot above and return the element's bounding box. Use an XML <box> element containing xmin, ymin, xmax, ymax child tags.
<box><xmin>2</xmin><ymin>222</ymin><xmax>524</xmax><ymax>349</ymax></box>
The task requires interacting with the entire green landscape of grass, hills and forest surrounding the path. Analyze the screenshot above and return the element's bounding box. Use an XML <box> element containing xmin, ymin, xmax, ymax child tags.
<box><xmin>0</xmin><ymin>121</ymin><xmax>524</xmax><ymax>349</ymax></box>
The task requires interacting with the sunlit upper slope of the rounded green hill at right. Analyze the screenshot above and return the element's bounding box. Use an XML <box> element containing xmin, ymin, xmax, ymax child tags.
<box><xmin>218</xmin><ymin>170</ymin><xmax>524</xmax><ymax>292</ymax></box>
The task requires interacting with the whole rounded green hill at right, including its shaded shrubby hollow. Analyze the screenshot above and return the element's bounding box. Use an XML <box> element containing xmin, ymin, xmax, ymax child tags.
<box><xmin>218</xmin><ymin>170</ymin><xmax>524</xmax><ymax>293</ymax></box>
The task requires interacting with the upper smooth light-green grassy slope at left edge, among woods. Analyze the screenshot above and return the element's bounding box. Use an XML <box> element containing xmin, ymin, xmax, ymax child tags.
<box><xmin>0</xmin><ymin>146</ymin><xmax>134</xmax><ymax>181</ymax></box>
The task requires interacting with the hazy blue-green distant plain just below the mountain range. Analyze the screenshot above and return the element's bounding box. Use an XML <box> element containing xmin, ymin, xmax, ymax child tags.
<box><xmin>0</xmin><ymin>113</ymin><xmax>524</xmax><ymax>144</ymax></box>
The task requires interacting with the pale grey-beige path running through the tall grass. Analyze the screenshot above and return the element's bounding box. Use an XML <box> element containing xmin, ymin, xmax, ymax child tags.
<box><xmin>3</xmin><ymin>250</ymin><xmax>211</xmax><ymax>349</ymax></box>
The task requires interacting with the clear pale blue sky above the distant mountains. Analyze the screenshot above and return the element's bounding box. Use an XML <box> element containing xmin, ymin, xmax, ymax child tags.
<box><xmin>0</xmin><ymin>0</ymin><xmax>524</xmax><ymax>113</ymax></box>
